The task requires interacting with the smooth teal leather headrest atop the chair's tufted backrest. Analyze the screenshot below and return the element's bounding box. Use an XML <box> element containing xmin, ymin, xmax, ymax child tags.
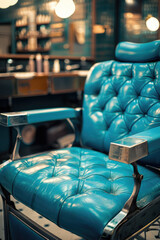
<box><xmin>115</xmin><ymin>40</ymin><xmax>160</xmax><ymax>62</ymax></box>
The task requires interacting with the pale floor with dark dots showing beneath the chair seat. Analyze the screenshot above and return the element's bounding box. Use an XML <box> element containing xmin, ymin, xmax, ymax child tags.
<box><xmin>0</xmin><ymin>197</ymin><xmax>160</xmax><ymax>240</ymax></box>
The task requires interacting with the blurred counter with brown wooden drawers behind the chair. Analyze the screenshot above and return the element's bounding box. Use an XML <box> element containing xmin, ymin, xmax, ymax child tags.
<box><xmin>0</xmin><ymin>70</ymin><xmax>88</xmax><ymax>98</ymax></box>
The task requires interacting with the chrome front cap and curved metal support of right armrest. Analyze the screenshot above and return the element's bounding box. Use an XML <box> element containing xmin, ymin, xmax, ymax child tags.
<box><xmin>103</xmin><ymin>137</ymin><xmax>148</xmax><ymax>239</ymax></box>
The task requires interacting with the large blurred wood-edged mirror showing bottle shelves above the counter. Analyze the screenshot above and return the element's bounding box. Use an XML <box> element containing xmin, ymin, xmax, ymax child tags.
<box><xmin>0</xmin><ymin>0</ymin><xmax>95</xmax><ymax>57</ymax></box>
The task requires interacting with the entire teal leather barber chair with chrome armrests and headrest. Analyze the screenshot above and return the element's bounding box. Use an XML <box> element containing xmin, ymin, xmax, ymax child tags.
<box><xmin>0</xmin><ymin>41</ymin><xmax>160</xmax><ymax>240</ymax></box>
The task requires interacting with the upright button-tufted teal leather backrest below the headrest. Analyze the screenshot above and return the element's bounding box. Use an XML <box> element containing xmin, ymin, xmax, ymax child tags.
<box><xmin>82</xmin><ymin>41</ymin><xmax>160</xmax><ymax>167</ymax></box>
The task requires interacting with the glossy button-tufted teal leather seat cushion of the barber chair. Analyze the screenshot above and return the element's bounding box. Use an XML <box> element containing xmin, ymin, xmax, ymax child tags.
<box><xmin>0</xmin><ymin>147</ymin><xmax>160</xmax><ymax>240</ymax></box>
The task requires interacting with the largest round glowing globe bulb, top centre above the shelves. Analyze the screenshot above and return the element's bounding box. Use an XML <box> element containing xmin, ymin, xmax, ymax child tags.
<box><xmin>55</xmin><ymin>0</ymin><xmax>75</xmax><ymax>18</ymax></box>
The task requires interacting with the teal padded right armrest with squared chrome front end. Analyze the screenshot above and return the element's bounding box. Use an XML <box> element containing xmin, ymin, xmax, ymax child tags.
<box><xmin>109</xmin><ymin>126</ymin><xmax>160</xmax><ymax>164</ymax></box>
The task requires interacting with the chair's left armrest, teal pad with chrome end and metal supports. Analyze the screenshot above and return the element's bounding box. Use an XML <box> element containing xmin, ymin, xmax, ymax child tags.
<box><xmin>0</xmin><ymin>108</ymin><xmax>82</xmax><ymax>160</ymax></box>
